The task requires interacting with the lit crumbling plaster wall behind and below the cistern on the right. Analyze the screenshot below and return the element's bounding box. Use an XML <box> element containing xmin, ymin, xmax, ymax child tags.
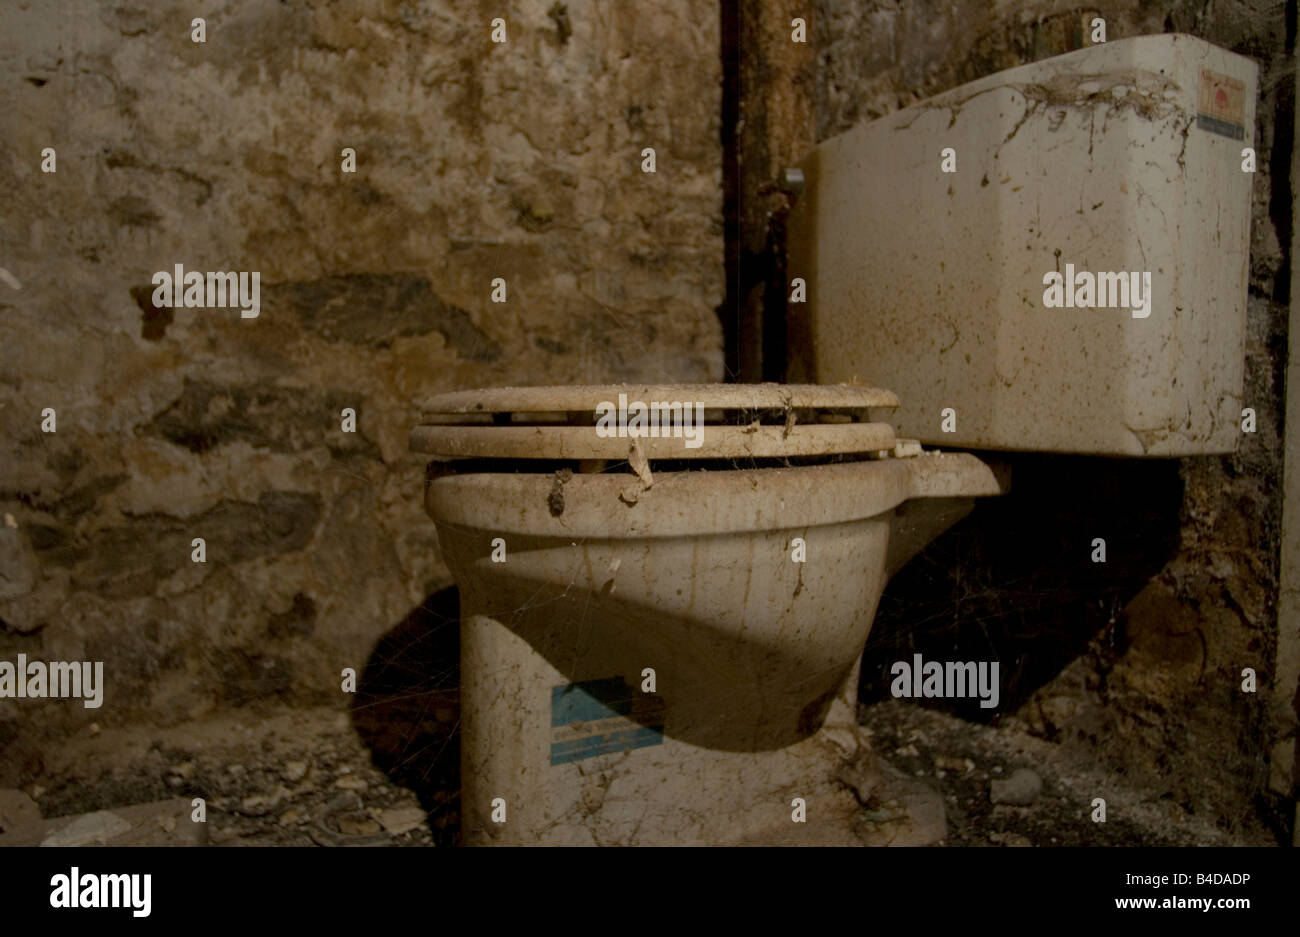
<box><xmin>815</xmin><ymin>0</ymin><xmax>1295</xmax><ymax>827</ymax></box>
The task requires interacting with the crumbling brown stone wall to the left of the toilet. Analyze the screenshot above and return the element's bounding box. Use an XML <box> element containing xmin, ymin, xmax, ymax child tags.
<box><xmin>0</xmin><ymin>0</ymin><xmax>723</xmax><ymax>786</ymax></box>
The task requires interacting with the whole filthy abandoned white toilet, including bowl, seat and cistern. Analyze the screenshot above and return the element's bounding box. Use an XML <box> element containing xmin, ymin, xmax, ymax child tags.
<box><xmin>411</xmin><ymin>35</ymin><xmax>1256</xmax><ymax>845</ymax></box>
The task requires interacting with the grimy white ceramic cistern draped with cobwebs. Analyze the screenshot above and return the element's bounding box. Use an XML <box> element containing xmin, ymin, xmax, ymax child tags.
<box><xmin>788</xmin><ymin>35</ymin><xmax>1257</xmax><ymax>456</ymax></box>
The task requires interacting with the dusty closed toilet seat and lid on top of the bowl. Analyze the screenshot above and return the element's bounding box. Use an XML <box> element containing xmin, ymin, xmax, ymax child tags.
<box><xmin>411</xmin><ymin>383</ymin><xmax>898</xmax><ymax>460</ymax></box>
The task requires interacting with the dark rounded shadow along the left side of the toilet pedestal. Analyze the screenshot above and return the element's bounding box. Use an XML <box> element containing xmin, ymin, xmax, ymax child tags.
<box><xmin>352</xmin><ymin>586</ymin><xmax>460</xmax><ymax>846</ymax></box>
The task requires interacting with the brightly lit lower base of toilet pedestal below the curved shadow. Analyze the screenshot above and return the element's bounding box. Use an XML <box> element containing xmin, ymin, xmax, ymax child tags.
<box><xmin>462</xmin><ymin>615</ymin><xmax>944</xmax><ymax>845</ymax></box>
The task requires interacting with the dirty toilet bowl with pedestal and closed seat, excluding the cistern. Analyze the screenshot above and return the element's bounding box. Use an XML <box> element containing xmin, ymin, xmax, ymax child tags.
<box><xmin>412</xmin><ymin>385</ymin><xmax>1005</xmax><ymax>842</ymax></box>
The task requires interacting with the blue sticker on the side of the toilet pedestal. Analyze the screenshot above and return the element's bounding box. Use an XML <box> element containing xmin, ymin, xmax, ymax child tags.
<box><xmin>551</xmin><ymin>677</ymin><xmax>663</xmax><ymax>764</ymax></box>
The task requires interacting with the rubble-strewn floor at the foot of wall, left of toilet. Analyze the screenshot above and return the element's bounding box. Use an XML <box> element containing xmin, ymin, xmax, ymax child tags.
<box><xmin>12</xmin><ymin>710</ymin><xmax>459</xmax><ymax>846</ymax></box>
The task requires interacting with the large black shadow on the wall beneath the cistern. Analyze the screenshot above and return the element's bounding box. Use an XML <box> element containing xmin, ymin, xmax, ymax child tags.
<box><xmin>859</xmin><ymin>455</ymin><xmax>1183</xmax><ymax>721</ymax></box>
